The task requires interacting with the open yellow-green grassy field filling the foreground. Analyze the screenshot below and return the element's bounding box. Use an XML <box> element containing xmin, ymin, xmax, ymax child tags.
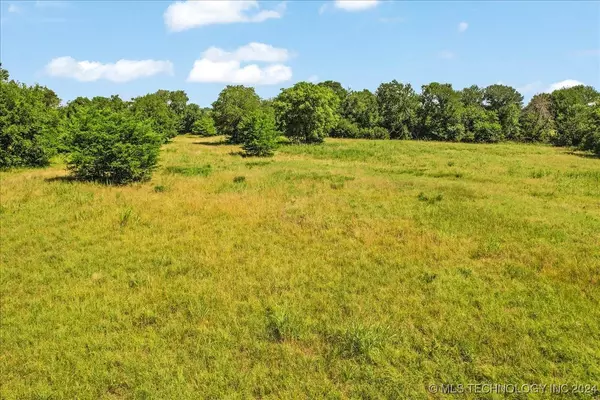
<box><xmin>0</xmin><ymin>136</ymin><xmax>600</xmax><ymax>399</ymax></box>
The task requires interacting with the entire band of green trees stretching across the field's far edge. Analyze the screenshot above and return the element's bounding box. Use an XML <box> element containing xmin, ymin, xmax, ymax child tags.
<box><xmin>0</xmin><ymin>65</ymin><xmax>600</xmax><ymax>183</ymax></box>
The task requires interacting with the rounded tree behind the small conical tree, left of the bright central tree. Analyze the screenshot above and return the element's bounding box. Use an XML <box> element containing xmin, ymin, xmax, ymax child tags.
<box><xmin>212</xmin><ymin>85</ymin><xmax>261</xmax><ymax>144</ymax></box>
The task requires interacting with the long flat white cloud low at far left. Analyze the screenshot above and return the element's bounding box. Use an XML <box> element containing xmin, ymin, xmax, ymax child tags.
<box><xmin>46</xmin><ymin>57</ymin><xmax>173</xmax><ymax>82</ymax></box>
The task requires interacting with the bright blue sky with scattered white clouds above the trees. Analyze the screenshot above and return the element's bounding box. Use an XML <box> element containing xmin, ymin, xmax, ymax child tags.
<box><xmin>0</xmin><ymin>0</ymin><xmax>600</xmax><ymax>106</ymax></box>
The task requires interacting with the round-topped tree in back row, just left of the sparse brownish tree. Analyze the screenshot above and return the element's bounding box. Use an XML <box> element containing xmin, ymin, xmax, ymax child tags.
<box><xmin>483</xmin><ymin>84</ymin><xmax>523</xmax><ymax>140</ymax></box>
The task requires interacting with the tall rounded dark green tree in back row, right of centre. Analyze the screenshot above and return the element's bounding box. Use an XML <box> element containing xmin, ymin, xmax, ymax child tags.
<box><xmin>375</xmin><ymin>80</ymin><xmax>419</xmax><ymax>139</ymax></box>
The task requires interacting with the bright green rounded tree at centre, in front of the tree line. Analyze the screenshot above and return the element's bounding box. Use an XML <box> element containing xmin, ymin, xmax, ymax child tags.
<box><xmin>273</xmin><ymin>82</ymin><xmax>339</xmax><ymax>143</ymax></box>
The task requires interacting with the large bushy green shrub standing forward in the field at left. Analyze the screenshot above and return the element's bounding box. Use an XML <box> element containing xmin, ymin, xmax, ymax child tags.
<box><xmin>67</xmin><ymin>109</ymin><xmax>163</xmax><ymax>184</ymax></box>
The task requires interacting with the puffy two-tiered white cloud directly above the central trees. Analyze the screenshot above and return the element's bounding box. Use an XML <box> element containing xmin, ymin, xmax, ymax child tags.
<box><xmin>188</xmin><ymin>43</ymin><xmax>292</xmax><ymax>85</ymax></box>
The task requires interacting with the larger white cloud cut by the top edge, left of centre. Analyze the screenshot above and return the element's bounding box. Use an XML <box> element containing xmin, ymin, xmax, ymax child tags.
<box><xmin>164</xmin><ymin>0</ymin><xmax>285</xmax><ymax>32</ymax></box>
